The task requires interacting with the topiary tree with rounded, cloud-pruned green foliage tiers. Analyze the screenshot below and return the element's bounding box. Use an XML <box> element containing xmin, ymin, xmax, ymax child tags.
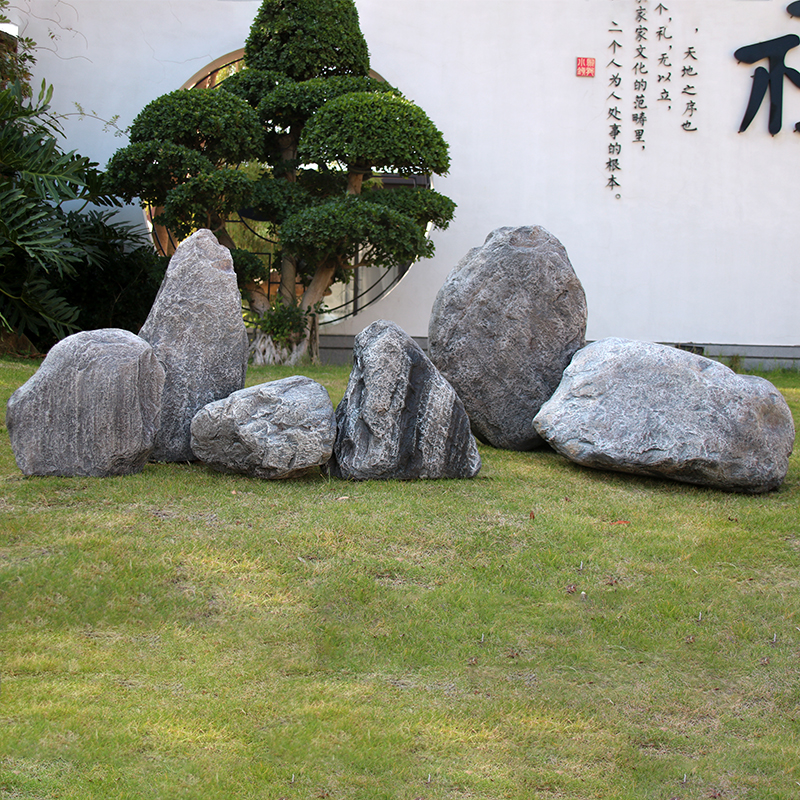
<box><xmin>108</xmin><ymin>0</ymin><xmax>455</xmax><ymax>360</ymax></box>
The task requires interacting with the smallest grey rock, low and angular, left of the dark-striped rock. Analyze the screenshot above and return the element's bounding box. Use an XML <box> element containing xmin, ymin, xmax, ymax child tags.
<box><xmin>191</xmin><ymin>375</ymin><xmax>336</xmax><ymax>478</ymax></box>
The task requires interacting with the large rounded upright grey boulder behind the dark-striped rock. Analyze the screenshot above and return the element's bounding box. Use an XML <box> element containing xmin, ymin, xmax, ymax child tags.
<box><xmin>428</xmin><ymin>226</ymin><xmax>586</xmax><ymax>450</ymax></box>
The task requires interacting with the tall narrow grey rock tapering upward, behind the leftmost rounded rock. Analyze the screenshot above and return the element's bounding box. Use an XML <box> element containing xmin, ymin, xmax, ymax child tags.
<box><xmin>139</xmin><ymin>230</ymin><xmax>248</xmax><ymax>461</ymax></box>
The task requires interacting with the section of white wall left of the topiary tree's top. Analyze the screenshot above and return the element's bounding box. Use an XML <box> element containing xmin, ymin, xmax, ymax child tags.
<box><xmin>18</xmin><ymin>0</ymin><xmax>259</xmax><ymax>175</ymax></box>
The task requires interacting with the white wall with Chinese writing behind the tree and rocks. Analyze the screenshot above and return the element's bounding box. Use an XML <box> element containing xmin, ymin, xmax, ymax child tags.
<box><xmin>20</xmin><ymin>0</ymin><xmax>800</xmax><ymax>345</ymax></box>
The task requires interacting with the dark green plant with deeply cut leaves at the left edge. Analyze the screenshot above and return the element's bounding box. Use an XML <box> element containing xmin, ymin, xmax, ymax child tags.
<box><xmin>0</xmin><ymin>83</ymin><xmax>115</xmax><ymax>350</ymax></box>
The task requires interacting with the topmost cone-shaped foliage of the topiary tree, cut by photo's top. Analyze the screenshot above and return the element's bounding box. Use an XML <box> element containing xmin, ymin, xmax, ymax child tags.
<box><xmin>245</xmin><ymin>0</ymin><xmax>369</xmax><ymax>81</ymax></box>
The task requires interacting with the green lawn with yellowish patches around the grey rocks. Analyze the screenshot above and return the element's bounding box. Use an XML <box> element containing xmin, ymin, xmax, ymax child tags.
<box><xmin>0</xmin><ymin>359</ymin><xmax>800</xmax><ymax>800</ymax></box>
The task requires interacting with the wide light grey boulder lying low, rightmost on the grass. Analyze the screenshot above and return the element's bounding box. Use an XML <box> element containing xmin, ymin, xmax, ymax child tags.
<box><xmin>533</xmin><ymin>339</ymin><xmax>795</xmax><ymax>493</ymax></box>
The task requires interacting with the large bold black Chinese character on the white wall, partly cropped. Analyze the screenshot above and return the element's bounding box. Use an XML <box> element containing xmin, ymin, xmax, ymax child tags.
<box><xmin>734</xmin><ymin>33</ymin><xmax>800</xmax><ymax>136</ymax></box>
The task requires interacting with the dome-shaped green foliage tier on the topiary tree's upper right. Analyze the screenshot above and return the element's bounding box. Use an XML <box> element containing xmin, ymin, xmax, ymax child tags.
<box><xmin>298</xmin><ymin>92</ymin><xmax>450</xmax><ymax>175</ymax></box>
